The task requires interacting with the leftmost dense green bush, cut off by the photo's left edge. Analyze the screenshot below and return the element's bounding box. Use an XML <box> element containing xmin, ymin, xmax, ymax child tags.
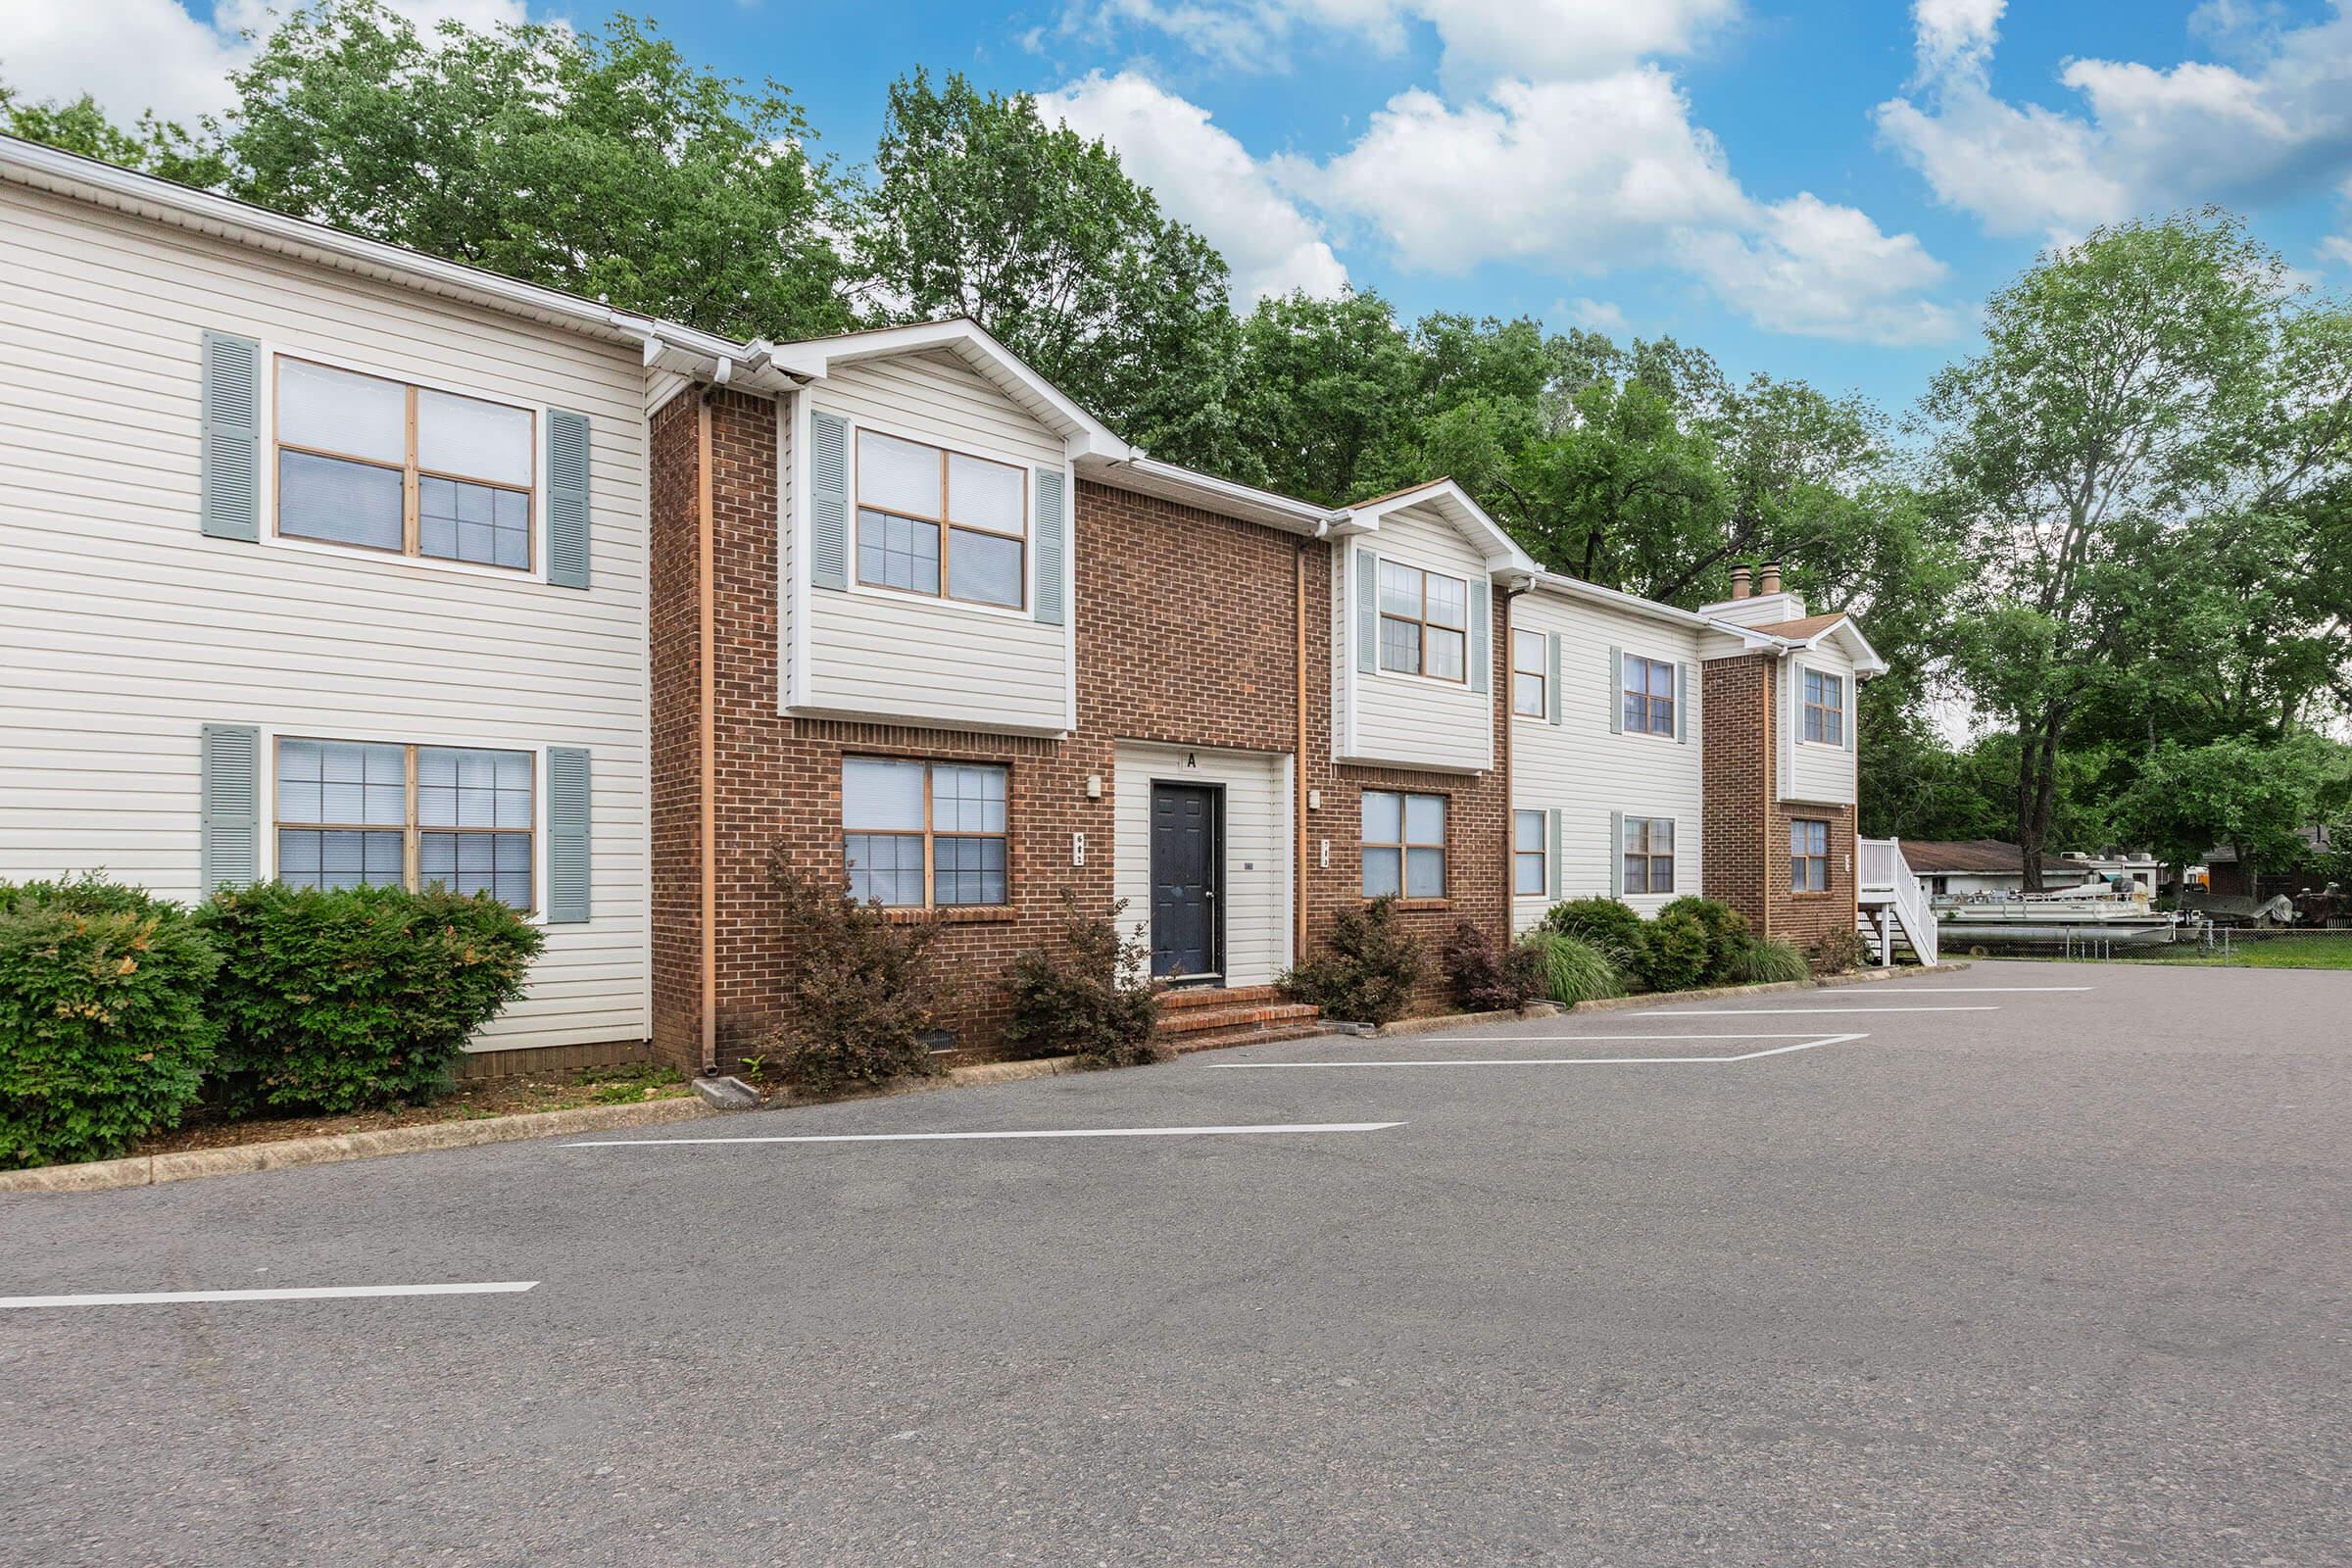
<box><xmin>0</xmin><ymin>877</ymin><xmax>219</xmax><ymax>1168</ymax></box>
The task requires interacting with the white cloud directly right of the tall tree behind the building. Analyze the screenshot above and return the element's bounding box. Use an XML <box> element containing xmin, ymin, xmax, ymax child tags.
<box><xmin>1037</xmin><ymin>71</ymin><xmax>1348</xmax><ymax>301</ymax></box>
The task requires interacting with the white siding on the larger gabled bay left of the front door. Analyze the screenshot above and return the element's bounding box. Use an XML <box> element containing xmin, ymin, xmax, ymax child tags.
<box><xmin>804</xmin><ymin>353</ymin><xmax>1070</xmax><ymax>733</ymax></box>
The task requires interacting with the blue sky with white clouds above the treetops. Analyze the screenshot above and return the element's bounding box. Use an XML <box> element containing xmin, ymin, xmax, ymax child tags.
<box><xmin>14</xmin><ymin>0</ymin><xmax>2352</xmax><ymax>409</ymax></box>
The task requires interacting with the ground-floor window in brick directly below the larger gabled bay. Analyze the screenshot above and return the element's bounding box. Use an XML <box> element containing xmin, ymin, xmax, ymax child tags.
<box><xmin>842</xmin><ymin>757</ymin><xmax>1009</xmax><ymax>909</ymax></box>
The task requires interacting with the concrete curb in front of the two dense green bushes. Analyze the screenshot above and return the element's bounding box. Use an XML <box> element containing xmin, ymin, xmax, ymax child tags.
<box><xmin>0</xmin><ymin>1098</ymin><xmax>715</xmax><ymax>1192</ymax></box>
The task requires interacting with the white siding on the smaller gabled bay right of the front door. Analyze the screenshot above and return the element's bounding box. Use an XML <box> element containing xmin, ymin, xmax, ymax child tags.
<box><xmin>1336</xmin><ymin>508</ymin><xmax>1494</xmax><ymax>773</ymax></box>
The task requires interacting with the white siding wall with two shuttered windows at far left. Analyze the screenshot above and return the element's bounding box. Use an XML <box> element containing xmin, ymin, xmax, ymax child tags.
<box><xmin>0</xmin><ymin>186</ymin><xmax>649</xmax><ymax>1049</ymax></box>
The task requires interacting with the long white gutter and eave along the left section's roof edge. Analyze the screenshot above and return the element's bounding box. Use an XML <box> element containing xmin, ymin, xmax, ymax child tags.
<box><xmin>0</xmin><ymin>136</ymin><xmax>788</xmax><ymax>390</ymax></box>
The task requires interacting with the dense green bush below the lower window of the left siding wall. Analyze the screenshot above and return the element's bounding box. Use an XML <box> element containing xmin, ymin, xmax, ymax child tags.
<box><xmin>195</xmin><ymin>882</ymin><xmax>546</xmax><ymax>1114</ymax></box>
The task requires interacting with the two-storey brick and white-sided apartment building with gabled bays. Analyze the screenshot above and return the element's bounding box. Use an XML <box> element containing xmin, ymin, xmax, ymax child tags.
<box><xmin>0</xmin><ymin>141</ymin><xmax>1880</xmax><ymax>1069</ymax></box>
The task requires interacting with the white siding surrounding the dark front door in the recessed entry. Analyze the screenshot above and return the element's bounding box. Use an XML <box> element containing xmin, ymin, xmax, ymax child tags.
<box><xmin>1110</xmin><ymin>741</ymin><xmax>1294</xmax><ymax>985</ymax></box>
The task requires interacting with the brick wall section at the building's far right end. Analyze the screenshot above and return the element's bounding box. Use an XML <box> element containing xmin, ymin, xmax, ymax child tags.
<box><xmin>1703</xmin><ymin>654</ymin><xmax>1860</xmax><ymax>948</ymax></box>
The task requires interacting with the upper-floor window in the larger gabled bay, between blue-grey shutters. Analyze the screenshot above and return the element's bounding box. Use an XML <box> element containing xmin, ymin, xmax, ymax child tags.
<box><xmin>858</xmin><ymin>430</ymin><xmax>1028</xmax><ymax>609</ymax></box>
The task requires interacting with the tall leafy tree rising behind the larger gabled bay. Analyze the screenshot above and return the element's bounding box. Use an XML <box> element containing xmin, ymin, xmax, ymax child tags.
<box><xmin>854</xmin><ymin>71</ymin><xmax>1233</xmax><ymax>459</ymax></box>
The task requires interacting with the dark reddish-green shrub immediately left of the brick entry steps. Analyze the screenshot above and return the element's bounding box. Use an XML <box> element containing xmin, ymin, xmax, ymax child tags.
<box><xmin>1004</xmin><ymin>889</ymin><xmax>1171</xmax><ymax>1067</ymax></box>
